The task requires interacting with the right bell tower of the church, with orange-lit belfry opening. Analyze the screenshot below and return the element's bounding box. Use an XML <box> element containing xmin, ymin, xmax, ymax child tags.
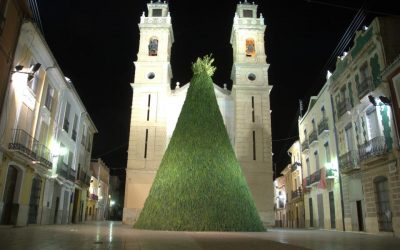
<box><xmin>231</xmin><ymin>1</ymin><xmax>275</xmax><ymax>226</ymax></box>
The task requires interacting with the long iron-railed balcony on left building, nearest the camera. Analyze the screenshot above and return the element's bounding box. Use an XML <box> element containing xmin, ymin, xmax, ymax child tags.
<box><xmin>8</xmin><ymin>129</ymin><xmax>52</xmax><ymax>168</ymax></box>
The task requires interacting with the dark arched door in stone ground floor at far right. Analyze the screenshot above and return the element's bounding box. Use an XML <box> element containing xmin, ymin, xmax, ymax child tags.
<box><xmin>374</xmin><ymin>177</ymin><xmax>393</xmax><ymax>232</ymax></box>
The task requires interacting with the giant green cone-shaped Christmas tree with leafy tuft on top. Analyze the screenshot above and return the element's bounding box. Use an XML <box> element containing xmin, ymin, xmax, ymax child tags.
<box><xmin>134</xmin><ymin>56</ymin><xmax>265</xmax><ymax>231</ymax></box>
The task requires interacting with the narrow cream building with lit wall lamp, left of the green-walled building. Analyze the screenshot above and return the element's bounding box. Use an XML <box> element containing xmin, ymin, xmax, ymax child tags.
<box><xmin>299</xmin><ymin>76</ymin><xmax>343</xmax><ymax>230</ymax></box>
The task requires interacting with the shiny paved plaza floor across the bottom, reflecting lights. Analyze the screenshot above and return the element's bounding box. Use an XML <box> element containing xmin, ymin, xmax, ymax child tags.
<box><xmin>0</xmin><ymin>222</ymin><xmax>400</xmax><ymax>250</ymax></box>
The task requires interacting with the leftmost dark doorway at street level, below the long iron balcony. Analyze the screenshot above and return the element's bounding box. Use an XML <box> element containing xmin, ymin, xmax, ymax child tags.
<box><xmin>1</xmin><ymin>166</ymin><xmax>18</xmax><ymax>225</ymax></box>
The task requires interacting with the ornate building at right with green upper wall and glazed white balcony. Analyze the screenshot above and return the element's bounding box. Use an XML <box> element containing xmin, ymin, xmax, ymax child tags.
<box><xmin>329</xmin><ymin>17</ymin><xmax>400</xmax><ymax>234</ymax></box>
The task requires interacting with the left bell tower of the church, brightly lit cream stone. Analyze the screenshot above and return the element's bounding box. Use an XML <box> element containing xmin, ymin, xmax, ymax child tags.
<box><xmin>123</xmin><ymin>1</ymin><xmax>174</xmax><ymax>224</ymax></box>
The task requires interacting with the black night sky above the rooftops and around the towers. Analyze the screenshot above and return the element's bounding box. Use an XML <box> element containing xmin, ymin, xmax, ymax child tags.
<box><xmin>37</xmin><ymin>0</ymin><xmax>400</xmax><ymax>179</ymax></box>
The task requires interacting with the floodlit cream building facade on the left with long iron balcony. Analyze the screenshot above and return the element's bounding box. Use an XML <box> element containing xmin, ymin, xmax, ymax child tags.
<box><xmin>0</xmin><ymin>21</ymin><xmax>97</xmax><ymax>226</ymax></box>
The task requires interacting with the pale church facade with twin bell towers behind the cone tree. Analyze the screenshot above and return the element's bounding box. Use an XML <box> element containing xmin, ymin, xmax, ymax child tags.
<box><xmin>123</xmin><ymin>1</ymin><xmax>274</xmax><ymax>226</ymax></box>
